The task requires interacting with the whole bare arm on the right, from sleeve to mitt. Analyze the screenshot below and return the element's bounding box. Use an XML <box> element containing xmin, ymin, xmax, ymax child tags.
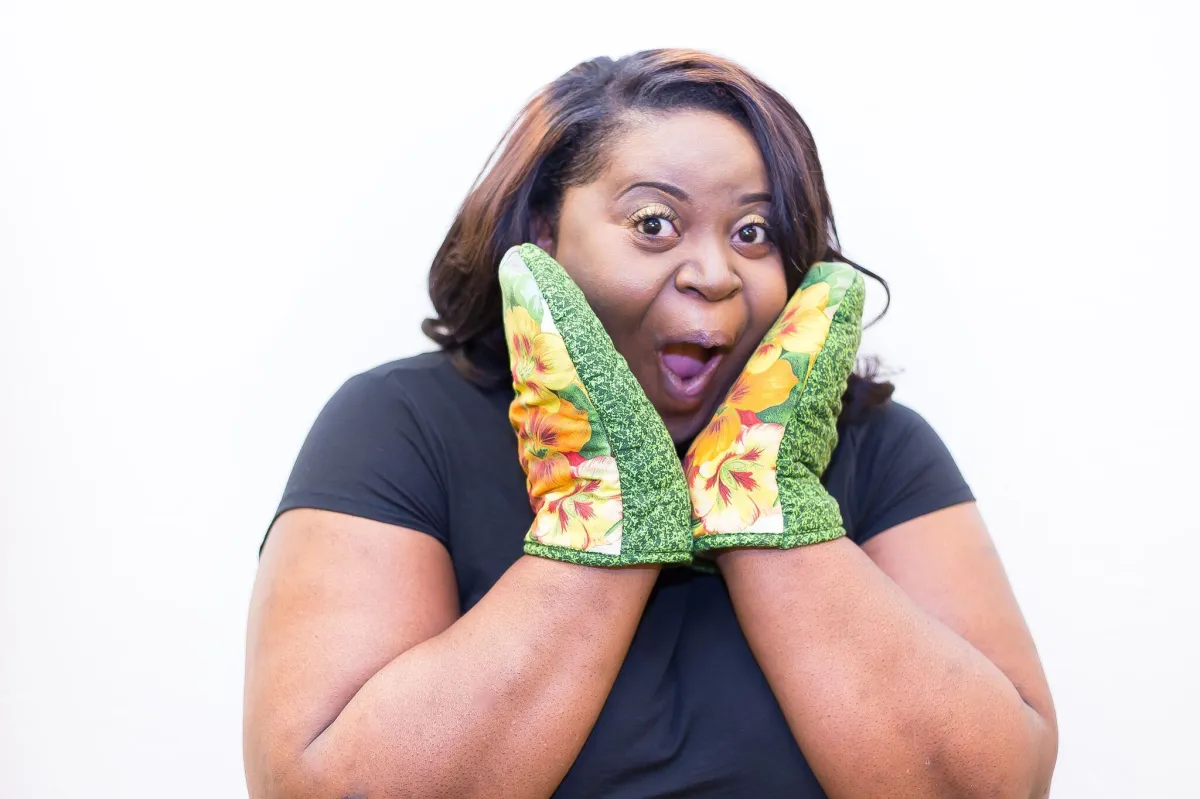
<box><xmin>719</xmin><ymin>503</ymin><xmax>1057</xmax><ymax>798</ymax></box>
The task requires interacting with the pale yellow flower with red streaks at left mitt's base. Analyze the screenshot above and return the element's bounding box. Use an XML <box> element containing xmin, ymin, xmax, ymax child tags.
<box><xmin>529</xmin><ymin>456</ymin><xmax>622</xmax><ymax>554</ymax></box>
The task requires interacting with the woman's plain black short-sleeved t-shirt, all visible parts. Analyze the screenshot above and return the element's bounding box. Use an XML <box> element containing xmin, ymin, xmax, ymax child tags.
<box><xmin>267</xmin><ymin>353</ymin><xmax>972</xmax><ymax>799</ymax></box>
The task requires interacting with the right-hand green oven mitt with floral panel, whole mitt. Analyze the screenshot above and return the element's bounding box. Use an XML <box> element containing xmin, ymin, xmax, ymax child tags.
<box><xmin>684</xmin><ymin>262</ymin><xmax>865</xmax><ymax>551</ymax></box>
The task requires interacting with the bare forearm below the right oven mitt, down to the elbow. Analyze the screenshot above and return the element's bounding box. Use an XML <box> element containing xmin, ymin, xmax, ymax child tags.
<box><xmin>719</xmin><ymin>539</ymin><xmax>1054</xmax><ymax>797</ymax></box>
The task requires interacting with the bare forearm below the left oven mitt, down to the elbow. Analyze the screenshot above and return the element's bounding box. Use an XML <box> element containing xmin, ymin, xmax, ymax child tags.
<box><xmin>281</xmin><ymin>557</ymin><xmax>659</xmax><ymax>798</ymax></box>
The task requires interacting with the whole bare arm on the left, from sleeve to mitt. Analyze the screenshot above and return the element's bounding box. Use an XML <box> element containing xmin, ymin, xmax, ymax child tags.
<box><xmin>245</xmin><ymin>510</ymin><xmax>659</xmax><ymax>799</ymax></box>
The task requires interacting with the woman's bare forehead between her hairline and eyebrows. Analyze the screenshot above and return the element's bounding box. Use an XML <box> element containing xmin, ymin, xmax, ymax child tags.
<box><xmin>601</xmin><ymin>110</ymin><xmax>770</xmax><ymax>196</ymax></box>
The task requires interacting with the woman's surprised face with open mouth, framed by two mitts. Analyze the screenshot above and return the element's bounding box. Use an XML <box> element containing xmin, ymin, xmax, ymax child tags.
<box><xmin>538</xmin><ymin>110</ymin><xmax>787</xmax><ymax>444</ymax></box>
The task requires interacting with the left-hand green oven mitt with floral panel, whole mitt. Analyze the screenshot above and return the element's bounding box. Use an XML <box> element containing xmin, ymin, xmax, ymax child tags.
<box><xmin>499</xmin><ymin>244</ymin><xmax>692</xmax><ymax>566</ymax></box>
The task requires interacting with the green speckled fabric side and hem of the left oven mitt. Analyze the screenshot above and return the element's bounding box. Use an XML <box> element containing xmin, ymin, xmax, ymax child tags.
<box><xmin>510</xmin><ymin>244</ymin><xmax>691</xmax><ymax>566</ymax></box>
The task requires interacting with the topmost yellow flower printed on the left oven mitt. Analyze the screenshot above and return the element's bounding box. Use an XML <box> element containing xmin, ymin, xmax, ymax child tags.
<box><xmin>504</xmin><ymin>306</ymin><xmax>577</xmax><ymax>411</ymax></box>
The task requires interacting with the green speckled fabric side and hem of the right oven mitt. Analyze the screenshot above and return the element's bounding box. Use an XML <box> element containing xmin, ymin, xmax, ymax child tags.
<box><xmin>694</xmin><ymin>262</ymin><xmax>866</xmax><ymax>551</ymax></box>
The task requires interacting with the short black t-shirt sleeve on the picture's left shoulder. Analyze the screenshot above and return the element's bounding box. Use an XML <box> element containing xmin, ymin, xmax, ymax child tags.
<box><xmin>264</xmin><ymin>372</ymin><xmax>448</xmax><ymax>545</ymax></box>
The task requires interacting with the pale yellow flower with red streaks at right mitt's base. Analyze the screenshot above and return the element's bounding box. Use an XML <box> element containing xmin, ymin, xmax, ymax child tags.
<box><xmin>689</xmin><ymin>423</ymin><xmax>784</xmax><ymax>536</ymax></box>
